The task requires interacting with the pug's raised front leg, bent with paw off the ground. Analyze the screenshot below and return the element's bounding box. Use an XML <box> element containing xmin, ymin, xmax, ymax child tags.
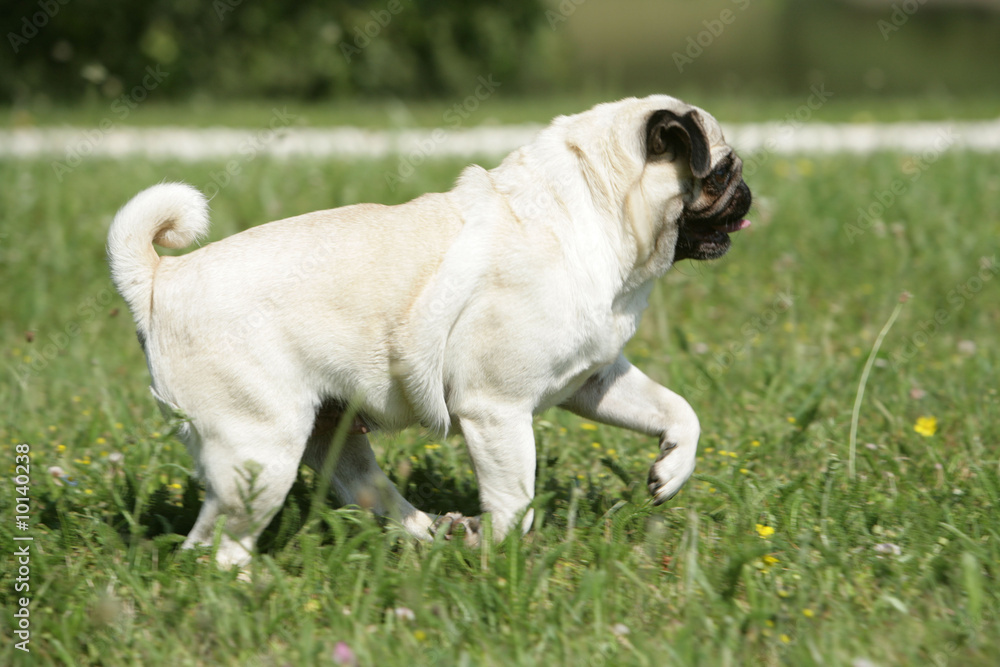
<box><xmin>562</xmin><ymin>356</ymin><xmax>701</xmax><ymax>505</ymax></box>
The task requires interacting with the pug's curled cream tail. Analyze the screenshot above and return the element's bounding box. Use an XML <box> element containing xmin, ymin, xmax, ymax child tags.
<box><xmin>108</xmin><ymin>183</ymin><xmax>208</xmax><ymax>339</ymax></box>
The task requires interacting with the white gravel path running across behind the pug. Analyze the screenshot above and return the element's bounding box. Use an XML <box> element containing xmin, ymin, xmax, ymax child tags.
<box><xmin>0</xmin><ymin>120</ymin><xmax>1000</xmax><ymax>166</ymax></box>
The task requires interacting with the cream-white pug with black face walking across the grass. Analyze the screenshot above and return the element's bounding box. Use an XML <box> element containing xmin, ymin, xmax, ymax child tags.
<box><xmin>108</xmin><ymin>96</ymin><xmax>751</xmax><ymax>565</ymax></box>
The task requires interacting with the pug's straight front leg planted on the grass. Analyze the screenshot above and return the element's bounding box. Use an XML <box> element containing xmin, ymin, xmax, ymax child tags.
<box><xmin>443</xmin><ymin>401</ymin><xmax>535</xmax><ymax>544</ymax></box>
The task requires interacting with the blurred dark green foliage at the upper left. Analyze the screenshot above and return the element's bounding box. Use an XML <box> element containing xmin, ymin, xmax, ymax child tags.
<box><xmin>0</xmin><ymin>0</ymin><xmax>553</xmax><ymax>102</ymax></box>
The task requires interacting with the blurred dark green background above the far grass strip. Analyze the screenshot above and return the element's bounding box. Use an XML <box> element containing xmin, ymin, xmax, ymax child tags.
<box><xmin>0</xmin><ymin>0</ymin><xmax>1000</xmax><ymax>118</ymax></box>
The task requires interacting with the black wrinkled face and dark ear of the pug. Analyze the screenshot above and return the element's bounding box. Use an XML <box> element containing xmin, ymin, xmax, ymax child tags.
<box><xmin>646</xmin><ymin>109</ymin><xmax>752</xmax><ymax>262</ymax></box>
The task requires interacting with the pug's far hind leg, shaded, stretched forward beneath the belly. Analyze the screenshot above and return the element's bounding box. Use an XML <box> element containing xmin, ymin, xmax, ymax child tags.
<box><xmin>304</xmin><ymin>407</ymin><xmax>434</xmax><ymax>540</ymax></box>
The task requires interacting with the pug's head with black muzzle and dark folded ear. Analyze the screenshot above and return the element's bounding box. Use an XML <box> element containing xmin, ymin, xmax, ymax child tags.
<box><xmin>564</xmin><ymin>95</ymin><xmax>751</xmax><ymax>273</ymax></box>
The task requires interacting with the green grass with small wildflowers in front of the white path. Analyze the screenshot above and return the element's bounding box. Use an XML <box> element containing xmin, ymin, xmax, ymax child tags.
<box><xmin>0</xmin><ymin>153</ymin><xmax>1000</xmax><ymax>667</ymax></box>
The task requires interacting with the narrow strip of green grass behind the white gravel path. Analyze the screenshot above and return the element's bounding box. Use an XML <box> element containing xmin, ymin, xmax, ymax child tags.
<box><xmin>7</xmin><ymin>91</ymin><xmax>1000</xmax><ymax>128</ymax></box>
